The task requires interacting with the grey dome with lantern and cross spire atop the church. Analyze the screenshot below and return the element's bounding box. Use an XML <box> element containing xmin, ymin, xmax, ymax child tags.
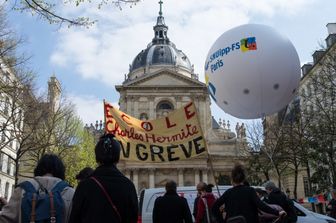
<box><xmin>129</xmin><ymin>3</ymin><xmax>193</xmax><ymax>73</ymax></box>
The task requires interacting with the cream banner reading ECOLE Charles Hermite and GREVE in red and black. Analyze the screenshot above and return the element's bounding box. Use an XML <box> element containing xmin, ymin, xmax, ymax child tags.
<box><xmin>104</xmin><ymin>102</ymin><xmax>206</xmax><ymax>162</ymax></box>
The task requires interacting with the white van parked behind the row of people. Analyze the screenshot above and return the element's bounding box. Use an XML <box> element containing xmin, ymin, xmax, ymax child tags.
<box><xmin>138</xmin><ymin>186</ymin><xmax>336</xmax><ymax>223</ymax></box>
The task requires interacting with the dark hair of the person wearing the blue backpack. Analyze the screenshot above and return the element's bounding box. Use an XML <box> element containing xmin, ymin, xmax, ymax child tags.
<box><xmin>34</xmin><ymin>154</ymin><xmax>65</xmax><ymax>180</ymax></box>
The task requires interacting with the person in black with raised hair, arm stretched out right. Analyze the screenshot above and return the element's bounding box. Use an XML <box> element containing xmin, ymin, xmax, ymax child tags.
<box><xmin>212</xmin><ymin>164</ymin><xmax>286</xmax><ymax>223</ymax></box>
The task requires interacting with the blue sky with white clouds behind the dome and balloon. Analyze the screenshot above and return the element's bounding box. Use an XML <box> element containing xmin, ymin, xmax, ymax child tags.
<box><xmin>3</xmin><ymin>0</ymin><xmax>336</xmax><ymax>128</ymax></box>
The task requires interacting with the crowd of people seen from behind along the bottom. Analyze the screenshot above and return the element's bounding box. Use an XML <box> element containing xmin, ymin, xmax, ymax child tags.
<box><xmin>0</xmin><ymin>134</ymin><xmax>336</xmax><ymax>223</ymax></box>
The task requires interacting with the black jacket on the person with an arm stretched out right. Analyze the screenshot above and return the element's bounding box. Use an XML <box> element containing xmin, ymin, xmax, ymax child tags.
<box><xmin>212</xmin><ymin>185</ymin><xmax>279</xmax><ymax>223</ymax></box>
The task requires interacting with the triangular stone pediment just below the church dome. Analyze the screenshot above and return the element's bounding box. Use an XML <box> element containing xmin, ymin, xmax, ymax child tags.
<box><xmin>124</xmin><ymin>70</ymin><xmax>205</xmax><ymax>87</ymax></box>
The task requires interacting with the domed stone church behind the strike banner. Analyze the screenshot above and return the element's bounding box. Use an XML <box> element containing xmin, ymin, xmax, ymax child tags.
<box><xmin>116</xmin><ymin>2</ymin><xmax>245</xmax><ymax>191</ymax></box>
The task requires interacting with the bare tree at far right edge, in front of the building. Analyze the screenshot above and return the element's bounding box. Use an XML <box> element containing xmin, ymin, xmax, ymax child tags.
<box><xmin>301</xmin><ymin>49</ymin><xmax>336</xmax><ymax>190</ymax></box>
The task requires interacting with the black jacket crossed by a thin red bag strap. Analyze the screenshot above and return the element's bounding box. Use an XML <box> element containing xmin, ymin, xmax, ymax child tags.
<box><xmin>69</xmin><ymin>165</ymin><xmax>138</xmax><ymax>223</ymax></box>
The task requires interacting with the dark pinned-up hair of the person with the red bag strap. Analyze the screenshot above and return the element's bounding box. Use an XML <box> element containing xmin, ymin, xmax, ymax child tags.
<box><xmin>95</xmin><ymin>133</ymin><xmax>120</xmax><ymax>164</ymax></box>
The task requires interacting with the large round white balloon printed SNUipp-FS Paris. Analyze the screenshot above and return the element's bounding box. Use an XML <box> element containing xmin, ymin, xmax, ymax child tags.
<box><xmin>205</xmin><ymin>24</ymin><xmax>300</xmax><ymax>119</ymax></box>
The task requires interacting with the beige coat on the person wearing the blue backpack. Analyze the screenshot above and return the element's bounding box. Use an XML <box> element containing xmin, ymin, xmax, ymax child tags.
<box><xmin>0</xmin><ymin>176</ymin><xmax>75</xmax><ymax>223</ymax></box>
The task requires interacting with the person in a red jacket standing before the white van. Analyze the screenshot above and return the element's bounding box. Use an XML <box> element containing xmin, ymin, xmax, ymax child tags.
<box><xmin>195</xmin><ymin>184</ymin><xmax>216</xmax><ymax>223</ymax></box>
